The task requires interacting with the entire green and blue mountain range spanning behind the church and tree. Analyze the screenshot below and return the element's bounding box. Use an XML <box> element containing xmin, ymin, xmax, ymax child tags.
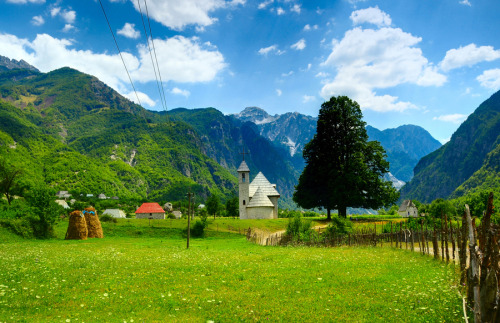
<box><xmin>0</xmin><ymin>57</ymin><xmax>500</xmax><ymax>213</ymax></box>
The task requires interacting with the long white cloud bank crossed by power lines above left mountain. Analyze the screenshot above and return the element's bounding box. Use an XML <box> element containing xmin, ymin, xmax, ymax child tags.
<box><xmin>0</xmin><ymin>33</ymin><xmax>226</xmax><ymax>103</ymax></box>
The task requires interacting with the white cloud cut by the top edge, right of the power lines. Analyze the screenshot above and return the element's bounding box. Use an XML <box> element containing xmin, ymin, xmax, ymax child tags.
<box><xmin>131</xmin><ymin>0</ymin><xmax>245</xmax><ymax>30</ymax></box>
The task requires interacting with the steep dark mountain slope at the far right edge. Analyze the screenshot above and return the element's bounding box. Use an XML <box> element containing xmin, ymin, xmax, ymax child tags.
<box><xmin>402</xmin><ymin>92</ymin><xmax>500</xmax><ymax>202</ymax></box>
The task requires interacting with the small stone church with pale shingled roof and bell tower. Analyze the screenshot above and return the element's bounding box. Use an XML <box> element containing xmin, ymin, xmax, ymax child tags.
<box><xmin>238</xmin><ymin>160</ymin><xmax>280</xmax><ymax>219</ymax></box>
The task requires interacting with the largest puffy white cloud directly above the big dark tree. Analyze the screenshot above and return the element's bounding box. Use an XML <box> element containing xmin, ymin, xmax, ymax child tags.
<box><xmin>317</xmin><ymin>27</ymin><xmax>446</xmax><ymax>112</ymax></box>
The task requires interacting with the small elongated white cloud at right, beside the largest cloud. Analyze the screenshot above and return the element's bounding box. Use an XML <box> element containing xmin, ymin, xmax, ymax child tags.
<box><xmin>439</xmin><ymin>44</ymin><xmax>500</xmax><ymax>71</ymax></box>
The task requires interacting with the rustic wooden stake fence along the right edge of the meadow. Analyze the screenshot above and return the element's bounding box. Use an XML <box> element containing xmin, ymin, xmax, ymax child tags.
<box><xmin>247</xmin><ymin>193</ymin><xmax>500</xmax><ymax>322</ymax></box>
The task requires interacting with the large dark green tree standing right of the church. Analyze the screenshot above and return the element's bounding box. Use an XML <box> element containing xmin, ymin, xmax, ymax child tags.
<box><xmin>293</xmin><ymin>96</ymin><xmax>399</xmax><ymax>219</ymax></box>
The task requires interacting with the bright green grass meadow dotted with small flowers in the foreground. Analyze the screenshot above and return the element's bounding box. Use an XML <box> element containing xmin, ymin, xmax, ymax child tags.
<box><xmin>0</xmin><ymin>220</ymin><xmax>462</xmax><ymax>322</ymax></box>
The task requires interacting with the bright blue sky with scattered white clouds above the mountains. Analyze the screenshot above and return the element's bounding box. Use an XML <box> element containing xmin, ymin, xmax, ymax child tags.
<box><xmin>0</xmin><ymin>0</ymin><xmax>500</xmax><ymax>142</ymax></box>
